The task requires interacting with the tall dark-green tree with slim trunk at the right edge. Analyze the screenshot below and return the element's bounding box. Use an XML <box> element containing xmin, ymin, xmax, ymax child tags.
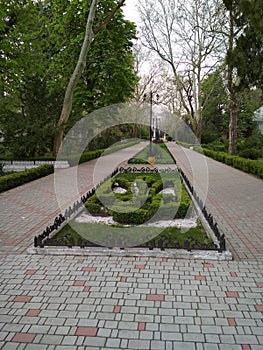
<box><xmin>223</xmin><ymin>0</ymin><xmax>263</xmax><ymax>155</ymax></box>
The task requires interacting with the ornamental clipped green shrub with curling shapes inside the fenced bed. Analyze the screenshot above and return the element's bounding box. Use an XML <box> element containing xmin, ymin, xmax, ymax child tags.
<box><xmin>85</xmin><ymin>173</ymin><xmax>191</xmax><ymax>225</ymax></box>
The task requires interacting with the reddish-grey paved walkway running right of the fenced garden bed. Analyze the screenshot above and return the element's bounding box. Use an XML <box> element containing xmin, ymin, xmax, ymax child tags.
<box><xmin>168</xmin><ymin>143</ymin><xmax>263</xmax><ymax>261</ymax></box>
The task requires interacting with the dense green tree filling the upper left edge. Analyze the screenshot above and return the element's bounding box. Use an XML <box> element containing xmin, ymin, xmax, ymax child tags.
<box><xmin>0</xmin><ymin>0</ymin><xmax>58</xmax><ymax>156</ymax></box>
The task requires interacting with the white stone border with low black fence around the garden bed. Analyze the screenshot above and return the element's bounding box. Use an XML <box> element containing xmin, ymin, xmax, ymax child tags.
<box><xmin>28</xmin><ymin>165</ymin><xmax>233</xmax><ymax>260</ymax></box>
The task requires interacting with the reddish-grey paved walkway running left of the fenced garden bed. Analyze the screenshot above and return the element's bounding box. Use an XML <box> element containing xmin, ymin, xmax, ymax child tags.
<box><xmin>0</xmin><ymin>144</ymin><xmax>145</xmax><ymax>256</ymax></box>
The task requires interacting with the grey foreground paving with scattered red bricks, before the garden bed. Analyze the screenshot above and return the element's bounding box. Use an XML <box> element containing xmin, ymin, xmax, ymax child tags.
<box><xmin>0</xmin><ymin>255</ymin><xmax>263</xmax><ymax>350</ymax></box>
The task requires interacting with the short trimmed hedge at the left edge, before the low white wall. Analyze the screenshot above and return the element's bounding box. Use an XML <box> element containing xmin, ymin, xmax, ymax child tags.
<box><xmin>0</xmin><ymin>164</ymin><xmax>54</xmax><ymax>192</ymax></box>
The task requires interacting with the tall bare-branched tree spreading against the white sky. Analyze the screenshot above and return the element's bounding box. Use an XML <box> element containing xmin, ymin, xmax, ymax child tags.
<box><xmin>140</xmin><ymin>0</ymin><xmax>225</xmax><ymax>140</ymax></box>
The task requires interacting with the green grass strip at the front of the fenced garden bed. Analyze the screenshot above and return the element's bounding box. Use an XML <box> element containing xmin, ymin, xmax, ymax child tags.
<box><xmin>45</xmin><ymin>223</ymin><xmax>217</xmax><ymax>250</ymax></box>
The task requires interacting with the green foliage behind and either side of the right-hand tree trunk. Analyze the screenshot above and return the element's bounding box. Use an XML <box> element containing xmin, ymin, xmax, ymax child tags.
<box><xmin>202</xmin><ymin>67</ymin><xmax>263</xmax><ymax>152</ymax></box>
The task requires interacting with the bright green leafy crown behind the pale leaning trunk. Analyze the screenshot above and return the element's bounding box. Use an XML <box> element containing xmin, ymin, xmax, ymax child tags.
<box><xmin>46</xmin><ymin>0</ymin><xmax>137</xmax><ymax>121</ymax></box>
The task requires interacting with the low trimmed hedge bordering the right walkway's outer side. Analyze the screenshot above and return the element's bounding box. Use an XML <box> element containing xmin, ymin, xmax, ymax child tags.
<box><xmin>203</xmin><ymin>148</ymin><xmax>263</xmax><ymax>179</ymax></box>
